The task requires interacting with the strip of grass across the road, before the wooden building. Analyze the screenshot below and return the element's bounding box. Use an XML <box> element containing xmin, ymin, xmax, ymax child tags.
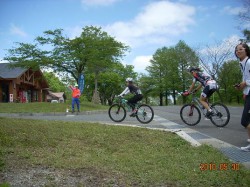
<box><xmin>0</xmin><ymin>102</ymin><xmax>108</xmax><ymax>113</ymax></box>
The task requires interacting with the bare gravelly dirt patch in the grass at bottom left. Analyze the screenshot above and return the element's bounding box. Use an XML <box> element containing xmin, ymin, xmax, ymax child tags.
<box><xmin>0</xmin><ymin>167</ymin><xmax>126</xmax><ymax>187</ymax></box>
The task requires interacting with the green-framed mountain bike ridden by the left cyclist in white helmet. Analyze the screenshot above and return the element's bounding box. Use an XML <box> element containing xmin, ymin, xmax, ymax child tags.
<box><xmin>108</xmin><ymin>96</ymin><xmax>154</xmax><ymax>124</ymax></box>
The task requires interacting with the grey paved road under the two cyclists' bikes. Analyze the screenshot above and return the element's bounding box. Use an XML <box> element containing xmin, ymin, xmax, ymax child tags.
<box><xmin>2</xmin><ymin>106</ymin><xmax>247</xmax><ymax>147</ymax></box>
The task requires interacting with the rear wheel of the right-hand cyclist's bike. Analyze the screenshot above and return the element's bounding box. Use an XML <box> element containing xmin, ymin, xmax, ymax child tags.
<box><xmin>210</xmin><ymin>103</ymin><xmax>230</xmax><ymax>127</ymax></box>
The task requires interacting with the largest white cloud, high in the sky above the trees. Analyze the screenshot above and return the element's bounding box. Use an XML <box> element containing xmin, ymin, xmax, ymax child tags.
<box><xmin>104</xmin><ymin>1</ymin><xmax>195</xmax><ymax>47</ymax></box>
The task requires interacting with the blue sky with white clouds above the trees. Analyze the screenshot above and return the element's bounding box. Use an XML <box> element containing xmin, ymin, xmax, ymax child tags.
<box><xmin>0</xmin><ymin>0</ymin><xmax>249</xmax><ymax>72</ymax></box>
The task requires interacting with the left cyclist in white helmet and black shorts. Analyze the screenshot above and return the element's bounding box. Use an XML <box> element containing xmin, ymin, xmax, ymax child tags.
<box><xmin>118</xmin><ymin>77</ymin><xmax>143</xmax><ymax>117</ymax></box>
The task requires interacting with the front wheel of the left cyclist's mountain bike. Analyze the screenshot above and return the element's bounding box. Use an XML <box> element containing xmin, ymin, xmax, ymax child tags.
<box><xmin>109</xmin><ymin>104</ymin><xmax>126</xmax><ymax>122</ymax></box>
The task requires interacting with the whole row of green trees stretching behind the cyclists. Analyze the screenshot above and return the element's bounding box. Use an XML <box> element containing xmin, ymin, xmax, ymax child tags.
<box><xmin>5</xmin><ymin>26</ymin><xmax>242</xmax><ymax>106</ymax></box>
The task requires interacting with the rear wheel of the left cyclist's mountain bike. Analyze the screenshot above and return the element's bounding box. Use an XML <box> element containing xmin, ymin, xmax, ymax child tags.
<box><xmin>136</xmin><ymin>104</ymin><xmax>154</xmax><ymax>124</ymax></box>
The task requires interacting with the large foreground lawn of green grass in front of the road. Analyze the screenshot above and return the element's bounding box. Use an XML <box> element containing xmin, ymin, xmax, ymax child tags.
<box><xmin>0</xmin><ymin>118</ymin><xmax>250</xmax><ymax>187</ymax></box>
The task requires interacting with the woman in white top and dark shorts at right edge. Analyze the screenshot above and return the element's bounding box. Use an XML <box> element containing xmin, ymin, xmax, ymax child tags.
<box><xmin>234</xmin><ymin>43</ymin><xmax>250</xmax><ymax>151</ymax></box>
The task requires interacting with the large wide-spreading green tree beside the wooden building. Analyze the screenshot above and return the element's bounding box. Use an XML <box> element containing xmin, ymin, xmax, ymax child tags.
<box><xmin>4</xmin><ymin>26</ymin><xmax>128</xmax><ymax>103</ymax></box>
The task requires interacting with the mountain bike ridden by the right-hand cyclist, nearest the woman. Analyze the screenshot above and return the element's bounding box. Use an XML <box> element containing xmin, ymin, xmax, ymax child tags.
<box><xmin>180</xmin><ymin>92</ymin><xmax>230</xmax><ymax>127</ymax></box>
